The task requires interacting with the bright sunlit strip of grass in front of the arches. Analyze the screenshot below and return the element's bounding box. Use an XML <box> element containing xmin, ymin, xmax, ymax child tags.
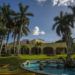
<box><xmin>19</xmin><ymin>54</ymin><xmax>66</xmax><ymax>60</ymax></box>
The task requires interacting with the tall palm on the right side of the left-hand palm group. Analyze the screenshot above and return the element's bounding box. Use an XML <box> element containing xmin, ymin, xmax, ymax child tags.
<box><xmin>14</xmin><ymin>3</ymin><xmax>33</xmax><ymax>54</ymax></box>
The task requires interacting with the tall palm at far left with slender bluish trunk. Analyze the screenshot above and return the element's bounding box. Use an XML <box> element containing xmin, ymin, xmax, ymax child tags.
<box><xmin>0</xmin><ymin>3</ymin><xmax>14</xmax><ymax>52</ymax></box>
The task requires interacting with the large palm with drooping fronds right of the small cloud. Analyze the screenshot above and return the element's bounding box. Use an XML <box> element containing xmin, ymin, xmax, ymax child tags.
<box><xmin>52</xmin><ymin>11</ymin><xmax>74</xmax><ymax>54</ymax></box>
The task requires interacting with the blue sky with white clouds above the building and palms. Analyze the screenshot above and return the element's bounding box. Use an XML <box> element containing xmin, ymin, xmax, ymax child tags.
<box><xmin>0</xmin><ymin>0</ymin><xmax>75</xmax><ymax>42</ymax></box>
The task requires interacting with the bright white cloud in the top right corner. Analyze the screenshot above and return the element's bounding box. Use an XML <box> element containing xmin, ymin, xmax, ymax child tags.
<box><xmin>52</xmin><ymin>0</ymin><xmax>75</xmax><ymax>6</ymax></box>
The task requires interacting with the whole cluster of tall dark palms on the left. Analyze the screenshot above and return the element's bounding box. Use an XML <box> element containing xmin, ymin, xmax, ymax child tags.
<box><xmin>0</xmin><ymin>3</ymin><xmax>33</xmax><ymax>55</ymax></box>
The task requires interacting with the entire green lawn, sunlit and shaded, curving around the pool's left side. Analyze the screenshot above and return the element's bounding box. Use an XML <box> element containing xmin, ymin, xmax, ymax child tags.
<box><xmin>0</xmin><ymin>54</ymin><xmax>75</xmax><ymax>75</ymax></box>
